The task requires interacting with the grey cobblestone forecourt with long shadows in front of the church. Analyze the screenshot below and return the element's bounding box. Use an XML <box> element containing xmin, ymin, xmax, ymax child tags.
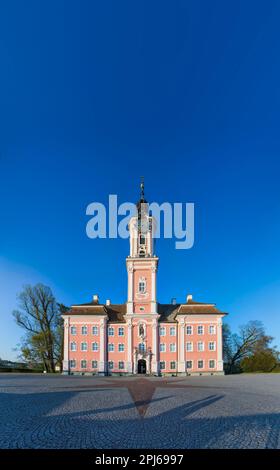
<box><xmin>0</xmin><ymin>374</ymin><xmax>280</xmax><ymax>449</ymax></box>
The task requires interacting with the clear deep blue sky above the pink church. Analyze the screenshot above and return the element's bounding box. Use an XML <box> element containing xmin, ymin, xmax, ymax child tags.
<box><xmin>0</xmin><ymin>0</ymin><xmax>280</xmax><ymax>358</ymax></box>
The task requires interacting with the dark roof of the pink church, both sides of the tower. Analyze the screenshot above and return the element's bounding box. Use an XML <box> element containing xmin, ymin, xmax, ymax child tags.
<box><xmin>67</xmin><ymin>299</ymin><xmax>227</xmax><ymax>323</ymax></box>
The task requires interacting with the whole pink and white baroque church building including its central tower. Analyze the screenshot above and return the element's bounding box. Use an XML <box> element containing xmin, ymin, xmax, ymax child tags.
<box><xmin>63</xmin><ymin>183</ymin><xmax>226</xmax><ymax>375</ymax></box>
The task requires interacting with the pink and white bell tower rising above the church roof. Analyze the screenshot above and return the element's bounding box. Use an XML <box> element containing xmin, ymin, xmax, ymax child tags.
<box><xmin>126</xmin><ymin>179</ymin><xmax>158</xmax><ymax>315</ymax></box>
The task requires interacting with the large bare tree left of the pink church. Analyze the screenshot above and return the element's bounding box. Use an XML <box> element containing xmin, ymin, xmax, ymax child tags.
<box><xmin>13</xmin><ymin>284</ymin><xmax>59</xmax><ymax>372</ymax></box>
